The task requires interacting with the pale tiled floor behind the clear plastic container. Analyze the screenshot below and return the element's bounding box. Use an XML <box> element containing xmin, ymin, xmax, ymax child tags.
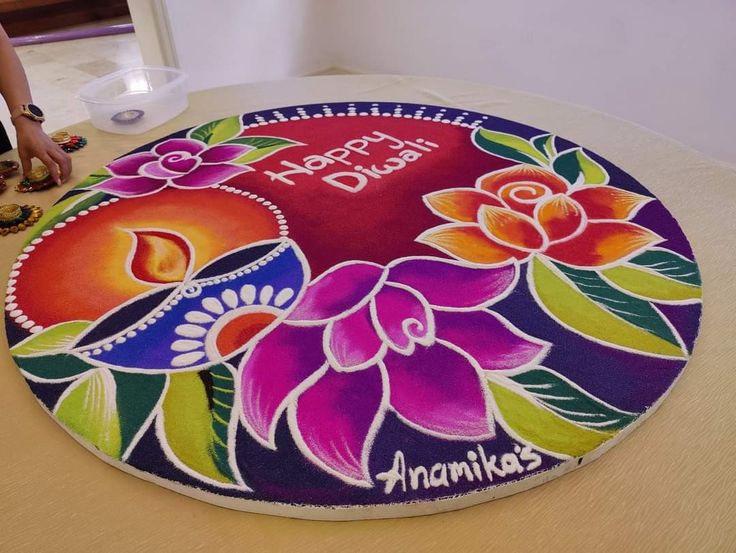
<box><xmin>0</xmin><ymin>33</ymin><xmax>143</xmax><ymax>144</ymax></box>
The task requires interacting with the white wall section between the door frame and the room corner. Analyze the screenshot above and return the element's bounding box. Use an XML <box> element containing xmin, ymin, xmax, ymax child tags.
<box><xmin>162</xmin><ymin>0</ymin><xmax>329</xmax><ymax>90</ymax></box>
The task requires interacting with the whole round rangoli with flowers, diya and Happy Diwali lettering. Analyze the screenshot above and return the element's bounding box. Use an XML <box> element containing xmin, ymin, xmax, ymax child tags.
<box><xmin>5</xmin><ymin>102</ymin><xmax>701</xmax><ymax>518</ymax></box>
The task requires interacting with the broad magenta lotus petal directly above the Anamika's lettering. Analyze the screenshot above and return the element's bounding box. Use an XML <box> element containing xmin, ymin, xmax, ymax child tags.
<box><xmin>384</xmin><ymin>344</ymin><xmax>494</xmax><ymax>439</ymax></box>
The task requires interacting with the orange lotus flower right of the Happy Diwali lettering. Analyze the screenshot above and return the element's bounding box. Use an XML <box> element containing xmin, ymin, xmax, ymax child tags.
<box><xmin>417</xmin><ymin>165</ymin><xmax>663</xmax><ymax>268</ymax></box>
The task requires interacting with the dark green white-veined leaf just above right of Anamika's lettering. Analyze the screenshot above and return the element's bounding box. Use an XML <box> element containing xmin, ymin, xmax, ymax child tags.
<box><xmin>510</xmin><ymin>368</ymin><xmax>637</xmax><ymax>431</ymax></box>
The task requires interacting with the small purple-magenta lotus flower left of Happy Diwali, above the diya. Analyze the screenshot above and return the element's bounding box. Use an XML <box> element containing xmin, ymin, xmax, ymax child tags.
<box><xmin>90</xmin><ymin>138</ymin><xmax>253</xmax><ymax>196</ymax></box>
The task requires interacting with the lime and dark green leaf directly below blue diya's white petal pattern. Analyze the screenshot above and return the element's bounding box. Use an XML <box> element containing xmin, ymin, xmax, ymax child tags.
<box><xmin>160</xmin><ymin>365</ymin><xmax>243</xmax><ymax>487</ymax></box>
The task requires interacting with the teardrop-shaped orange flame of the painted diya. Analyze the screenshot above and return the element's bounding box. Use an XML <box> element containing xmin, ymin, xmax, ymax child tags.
<box><xmin>128</xmin><ymin>229</ymin><xmax>193</xmax><ymax>284</ymax></box>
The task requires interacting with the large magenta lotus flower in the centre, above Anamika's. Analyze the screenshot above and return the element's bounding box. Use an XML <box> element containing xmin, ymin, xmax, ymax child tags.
<box><xmin>241</xmin><ymin>257</ymin><xmax>548</xmax><ymax>486</ymax></box>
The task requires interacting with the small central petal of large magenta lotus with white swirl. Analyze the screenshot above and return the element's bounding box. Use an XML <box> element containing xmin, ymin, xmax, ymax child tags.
<box><xmin>373</xmin><ymin>284</ymin><xmax>434</xmax><ymax>352</ymax></box>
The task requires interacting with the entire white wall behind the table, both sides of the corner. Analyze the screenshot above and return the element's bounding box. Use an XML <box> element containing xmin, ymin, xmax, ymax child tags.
<box><xmin>129</xmin><ymin>0</ymin><xmax>736</xmax><ymax>163</ymax></box>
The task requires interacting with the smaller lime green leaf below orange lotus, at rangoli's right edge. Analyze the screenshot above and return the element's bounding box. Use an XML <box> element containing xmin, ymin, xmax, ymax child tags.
<box><xmin>603</xmin><ymin>265</ymin><xmax>701</xmax><ymax>303</ymax></box>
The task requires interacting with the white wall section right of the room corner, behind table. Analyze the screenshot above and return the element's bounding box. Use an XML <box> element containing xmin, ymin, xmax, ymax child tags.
<box><xmin>331</xmin><ymin>0</ymin><xmax>736</xmax><ymax>163</ymax></box>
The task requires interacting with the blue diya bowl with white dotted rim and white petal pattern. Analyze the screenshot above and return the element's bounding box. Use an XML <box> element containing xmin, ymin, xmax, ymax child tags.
<box><xmin>74</xmin><ymin>241</ymin><xmax>309</xmax><ymax>370</ymax></box>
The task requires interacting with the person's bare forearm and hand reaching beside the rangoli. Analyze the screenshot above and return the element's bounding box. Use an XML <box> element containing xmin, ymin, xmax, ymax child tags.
<box><xmin>0</xmin><ymin>25</ymin><xmax>72</xmax><ymax>184</ymax></box>
